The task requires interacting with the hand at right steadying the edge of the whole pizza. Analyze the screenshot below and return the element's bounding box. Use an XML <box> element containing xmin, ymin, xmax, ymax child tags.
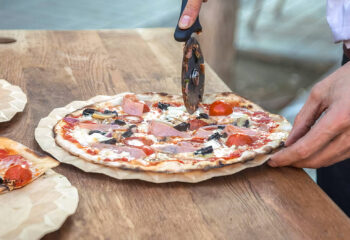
<box><xmin>268</xmin><ymin>63</ymin><xmax>350</xmax><ymax>168</ymax></box>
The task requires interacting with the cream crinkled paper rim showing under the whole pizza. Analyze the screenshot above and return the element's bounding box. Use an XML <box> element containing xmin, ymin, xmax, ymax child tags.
<box><xmin>35</xmin><ymin>93</ymin><xmax>269</xmax><ymax>183</ymax></box>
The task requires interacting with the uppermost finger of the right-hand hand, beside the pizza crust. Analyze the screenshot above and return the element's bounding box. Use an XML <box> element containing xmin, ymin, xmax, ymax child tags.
<box><xmin>286</xmin><ymin>89</ymin><xmax>324</xmax><ymax>147</ymax></box>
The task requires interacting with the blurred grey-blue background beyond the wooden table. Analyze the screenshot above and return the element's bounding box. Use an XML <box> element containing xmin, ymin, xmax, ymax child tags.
<box><xmin>0</xmin><ymin>0</ymin><xmax>342</xmax><ymax>178</ymax></box>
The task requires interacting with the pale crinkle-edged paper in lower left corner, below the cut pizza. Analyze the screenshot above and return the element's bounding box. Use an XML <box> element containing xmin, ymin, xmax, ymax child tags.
<box><xmin>0</xmin><ymin>170</ymin><xmax>79</xmax><ymax>240</ymax></box>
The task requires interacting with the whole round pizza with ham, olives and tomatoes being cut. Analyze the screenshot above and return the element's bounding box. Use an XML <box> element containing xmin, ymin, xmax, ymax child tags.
<box><xmin>53</xmin><ymin>92</ymin><xmax>291</xmax><ymax>174</ymax></box>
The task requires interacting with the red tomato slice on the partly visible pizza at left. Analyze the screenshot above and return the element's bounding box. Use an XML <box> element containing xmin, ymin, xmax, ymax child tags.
<box><xmin>4</xmin><ymin>165</ymin><xmax>32</xmax><ymax>187</ymax></box>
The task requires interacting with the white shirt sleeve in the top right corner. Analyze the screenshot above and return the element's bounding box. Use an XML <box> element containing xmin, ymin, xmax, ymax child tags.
<box><xmin>327</xmin><ymin>0</ymin><xmax>350</xmax><ymax>48</ymax></box>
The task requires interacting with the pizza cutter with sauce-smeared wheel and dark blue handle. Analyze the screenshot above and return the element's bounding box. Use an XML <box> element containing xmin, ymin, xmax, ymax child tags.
<box><xmin>174</xmin><ymin>0</ymin><xmax>204</xmax><ymax>114</ymax></box>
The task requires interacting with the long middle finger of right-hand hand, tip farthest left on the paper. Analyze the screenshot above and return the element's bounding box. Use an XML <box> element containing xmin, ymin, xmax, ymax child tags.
<box><xmin>269</xmin><ymin>107</ymin><xmax>350</xmax><ymax>166</ymax></box>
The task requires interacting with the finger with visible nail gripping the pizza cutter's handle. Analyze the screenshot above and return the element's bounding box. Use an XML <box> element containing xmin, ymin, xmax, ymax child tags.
<box><xmin>179</xmin><ymin>0</ymin><xmax>203</xmax><ymax>29</ymax></box>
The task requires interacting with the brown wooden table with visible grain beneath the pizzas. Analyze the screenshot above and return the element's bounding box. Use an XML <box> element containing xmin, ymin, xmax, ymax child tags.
<box><xmin>0</xmin><ymin>29</ymin><xmax>350</xmax><ymax>239</ymax></box>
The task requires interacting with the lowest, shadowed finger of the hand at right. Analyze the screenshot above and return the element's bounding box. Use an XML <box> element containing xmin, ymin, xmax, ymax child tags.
<box><xmin>292</xmin><ymin>126</ymin><xmax>350</xmax><ymax>168</ymax></box>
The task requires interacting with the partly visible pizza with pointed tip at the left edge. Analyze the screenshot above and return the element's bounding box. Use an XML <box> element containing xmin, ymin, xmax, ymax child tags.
<box><xmin>0</xmin><ymin>137</ymin><xmax>58</xmax><ymax>194</ymax></box>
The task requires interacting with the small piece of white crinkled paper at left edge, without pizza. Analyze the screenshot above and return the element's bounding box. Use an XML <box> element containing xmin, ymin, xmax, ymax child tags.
<box><xmin>0</xmin><ymin>79</ymin><xmax>27</xmax><ymax>122</ymax></box>
